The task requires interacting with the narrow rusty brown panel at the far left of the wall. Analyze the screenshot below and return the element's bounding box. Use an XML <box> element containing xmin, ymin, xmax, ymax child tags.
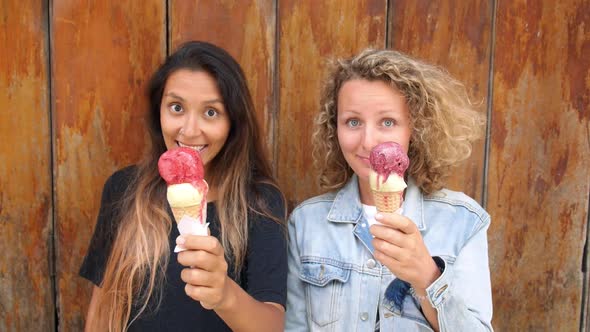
<box><xmin>0</xmin><ymin>0</ymin><xmax>55</xmax><ymax>331</ymax></box>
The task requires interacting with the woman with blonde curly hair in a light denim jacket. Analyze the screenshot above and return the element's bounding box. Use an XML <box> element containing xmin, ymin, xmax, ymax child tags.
<box><xmin>286</xmin><ymin>49</ymin><xmax>492</xmax><ymax>331</ymax></box>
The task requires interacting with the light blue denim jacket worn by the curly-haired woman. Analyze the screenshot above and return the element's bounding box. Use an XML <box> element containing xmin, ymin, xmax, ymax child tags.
<box><xmin>286</xmin><ymin>176</ymin><xmax>492</xmax><ymax>331</ymax></box>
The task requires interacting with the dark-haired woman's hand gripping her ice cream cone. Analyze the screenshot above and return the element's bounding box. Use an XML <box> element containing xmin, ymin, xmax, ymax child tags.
<box><xmin>176</xmin><ymin>235</ymin><xmax>229</xmax><ymax>309</ymax></box>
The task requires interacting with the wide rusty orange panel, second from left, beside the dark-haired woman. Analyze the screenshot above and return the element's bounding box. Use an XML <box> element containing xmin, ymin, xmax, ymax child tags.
<box><xmin>51</xmin><ymin>0</ymin><xmax>166</xmax><ymax>331</ymax></box>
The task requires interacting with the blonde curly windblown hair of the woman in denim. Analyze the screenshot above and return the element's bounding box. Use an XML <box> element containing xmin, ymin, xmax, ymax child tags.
<box><xmin>312</xmin><ymin>49</ymin><xmax>485</xmax><ymax>194</ymax></box>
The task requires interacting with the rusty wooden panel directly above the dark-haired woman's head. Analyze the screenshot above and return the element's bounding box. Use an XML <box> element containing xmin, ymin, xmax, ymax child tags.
<box><xmin>169</xmin><ymin>0</ymin><xmax>277</xmax><ymax>157</ymax></box>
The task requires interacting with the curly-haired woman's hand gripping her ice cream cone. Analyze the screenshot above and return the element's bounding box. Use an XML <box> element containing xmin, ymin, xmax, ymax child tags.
<box><xmin>370</xmin><ymin>212</ymin><xmax>440</xmax><ymax>289</ymax></box>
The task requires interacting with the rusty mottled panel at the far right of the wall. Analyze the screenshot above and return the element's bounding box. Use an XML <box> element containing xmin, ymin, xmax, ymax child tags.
<box><xmin>487</xmin><ymin>0</ymin><xmax>590</xmax><ymax>331</ymax></box>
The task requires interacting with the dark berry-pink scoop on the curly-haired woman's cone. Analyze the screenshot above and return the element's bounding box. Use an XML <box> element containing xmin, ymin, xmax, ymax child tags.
<box><xmin>369</xmin><ymin>142</ymin><xmax>410</xmax><ymax>181</ymax></box>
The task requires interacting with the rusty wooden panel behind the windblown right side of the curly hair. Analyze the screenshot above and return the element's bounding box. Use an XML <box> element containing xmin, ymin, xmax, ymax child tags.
<box><xmin>388</xmin><ymin>0</ymin><xmax>493</xmax><ymax>202</ymax></box>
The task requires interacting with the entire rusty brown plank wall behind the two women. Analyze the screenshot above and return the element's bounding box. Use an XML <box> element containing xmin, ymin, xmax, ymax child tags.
<box><xmin>0</xmin><ymin>0</ymin><xmax>590</xmax><ymax>331</ymax></box>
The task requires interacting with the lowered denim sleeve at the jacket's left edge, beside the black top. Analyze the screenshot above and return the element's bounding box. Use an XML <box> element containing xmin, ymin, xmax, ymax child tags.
<box><xmin>285</xmin><ymin>216</ymin><xmax>309</xmax><ymax>331</ymax></box>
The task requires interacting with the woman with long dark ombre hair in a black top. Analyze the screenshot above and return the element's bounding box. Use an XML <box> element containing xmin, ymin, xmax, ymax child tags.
<box><xmin>80</xmin><ymin>42</ymin><xmax>287</xmax><ymax>331</ymax></box>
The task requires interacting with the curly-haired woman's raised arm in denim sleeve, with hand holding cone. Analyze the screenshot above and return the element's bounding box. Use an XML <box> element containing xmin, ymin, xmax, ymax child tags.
<box><xmin>371</xmin><ymin>213</ymin><xmax>492</xmax><ymax>331</ymax></box>
